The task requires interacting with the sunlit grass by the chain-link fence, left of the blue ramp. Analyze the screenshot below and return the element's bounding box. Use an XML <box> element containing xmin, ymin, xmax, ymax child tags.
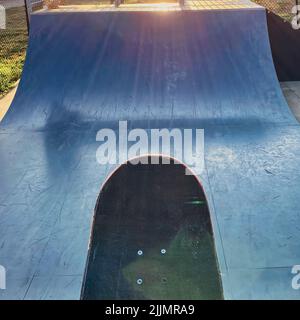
<box><xmin>0</xmin><ymin>7</ymin><xmax>28</xmax><ymax>97</ymax></box>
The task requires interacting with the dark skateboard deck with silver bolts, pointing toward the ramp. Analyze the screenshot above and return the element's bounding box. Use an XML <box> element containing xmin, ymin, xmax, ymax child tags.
<box><xmin>82</xmin><ymin>158</ymin><xmax>223</xmax><ymax>299</ymax></box>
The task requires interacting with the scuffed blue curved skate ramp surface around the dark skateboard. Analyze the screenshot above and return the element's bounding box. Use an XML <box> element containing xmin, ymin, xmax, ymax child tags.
<box><xmin>0</xmin><ymin>9</ymin><xmax>300</xmax><ymax>299</ymax></box>
